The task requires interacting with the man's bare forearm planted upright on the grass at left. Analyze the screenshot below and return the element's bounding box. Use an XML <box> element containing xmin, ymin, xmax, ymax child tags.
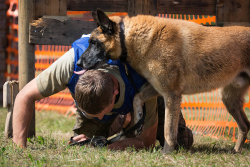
<box><xmin>13</xmin><ymin>79</ymin><xmax>43</xmax><ymax>147</ymax></box>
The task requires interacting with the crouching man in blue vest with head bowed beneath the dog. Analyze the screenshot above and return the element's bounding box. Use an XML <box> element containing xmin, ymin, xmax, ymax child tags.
<box><xmin>13</xmin><ymin>36</ymin><xmax>192</xmax><ymax>150</ymax></box>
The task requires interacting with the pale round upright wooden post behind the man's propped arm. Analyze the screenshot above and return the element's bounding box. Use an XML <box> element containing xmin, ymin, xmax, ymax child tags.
<box><xmin>18</xmin><ymin>0</ymin><xmax>35</xmax><ymax>137</ymax></box>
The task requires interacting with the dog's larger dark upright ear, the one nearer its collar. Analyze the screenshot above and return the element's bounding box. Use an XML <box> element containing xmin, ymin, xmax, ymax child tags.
<box><xmin>97</xmin><ymin>9</ymin><xmax>114</xmax><ymax>34</ymax></box>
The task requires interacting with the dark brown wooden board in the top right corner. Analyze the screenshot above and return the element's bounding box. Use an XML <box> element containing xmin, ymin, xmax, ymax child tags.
<box><xmin>217</xmin><ymin>0</ymin><xmax>250</xmax><ymax>26</ymax></box>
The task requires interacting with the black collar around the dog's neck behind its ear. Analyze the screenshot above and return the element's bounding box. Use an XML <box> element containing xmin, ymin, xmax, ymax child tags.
<box><xmin>119</xmin><ymin>21</ymin><xmax>128</xmax><ymax>64</ymax></box>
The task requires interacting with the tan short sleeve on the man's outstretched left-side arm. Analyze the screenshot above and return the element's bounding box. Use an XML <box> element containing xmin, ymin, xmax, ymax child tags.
<box><xmin>36</xmin><ymin>48</ymin><xmax>74</xmax><ymax>97</ymax></box>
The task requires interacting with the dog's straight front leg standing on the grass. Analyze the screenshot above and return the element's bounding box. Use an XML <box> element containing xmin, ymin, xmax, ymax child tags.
<box><xmin>163</xmin><ymin>91</ymin><xmax>182</xmax><ymax>154</ymax></box>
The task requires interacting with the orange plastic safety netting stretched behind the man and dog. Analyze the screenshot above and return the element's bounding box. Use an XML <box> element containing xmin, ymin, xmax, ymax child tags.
<box><xmin>5</xmin><ymin>0</ymin><xmax>250</xmax><ymax>141</ymax></box>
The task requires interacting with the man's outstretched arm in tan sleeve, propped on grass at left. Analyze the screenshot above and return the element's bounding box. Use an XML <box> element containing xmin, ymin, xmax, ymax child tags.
<box><xmin>13</xmin><ymin>48</ymin><xmax>74</xmax><ymax>146</ymax></box>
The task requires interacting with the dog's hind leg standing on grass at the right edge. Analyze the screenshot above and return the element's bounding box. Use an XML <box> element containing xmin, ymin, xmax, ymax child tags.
<box><xmin>221</xmin><ymin>77</ymin><xmax>250</xmax><ymax>152</ymax></box>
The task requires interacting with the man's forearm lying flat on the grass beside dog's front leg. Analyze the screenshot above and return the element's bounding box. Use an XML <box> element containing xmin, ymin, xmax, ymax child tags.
<box><xmin>108</xmin><ymin>121</ymin><xmax>158</xmax><ymax>150</ymax></box>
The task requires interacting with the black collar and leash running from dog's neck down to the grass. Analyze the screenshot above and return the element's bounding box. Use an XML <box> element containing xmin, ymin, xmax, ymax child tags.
<box><xmin>70</xmin><ymin>22</ymin><xmax>146</xmax><ymax>147</ymax></box>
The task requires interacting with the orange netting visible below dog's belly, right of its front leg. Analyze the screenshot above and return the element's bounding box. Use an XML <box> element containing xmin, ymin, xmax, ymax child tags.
<box><xmin>181</xmin><ymin>90</ymin><xmax>250</xmax><ymax>142</ymax></box>
